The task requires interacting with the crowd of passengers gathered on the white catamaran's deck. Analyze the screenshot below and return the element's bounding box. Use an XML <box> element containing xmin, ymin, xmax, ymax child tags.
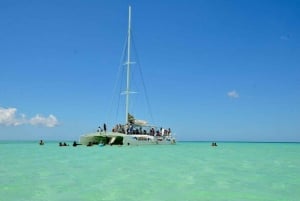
<box><xmin>112</xmin><ymin>124</ymin><xmax>171</xmax><ymax>136</ymax></box>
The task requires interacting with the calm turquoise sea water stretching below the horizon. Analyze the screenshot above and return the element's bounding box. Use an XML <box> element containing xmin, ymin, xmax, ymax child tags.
<box><xmin>0</xmin><ymin>142</ymin><xmax>300</xmax><ymax>201</ymax></box>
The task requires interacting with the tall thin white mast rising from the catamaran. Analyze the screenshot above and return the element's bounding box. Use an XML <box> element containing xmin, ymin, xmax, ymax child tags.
<box><xmin>125</xmin><ymin>6</ymin><xmax>131</xmax><ymax>123</ymax></box>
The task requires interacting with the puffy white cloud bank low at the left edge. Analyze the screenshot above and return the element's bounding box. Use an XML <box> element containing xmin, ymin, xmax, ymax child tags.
<box><xmin>0</xmin><ymin>107</ymin><xmax>59</xmax><ymax>127</ymax></box>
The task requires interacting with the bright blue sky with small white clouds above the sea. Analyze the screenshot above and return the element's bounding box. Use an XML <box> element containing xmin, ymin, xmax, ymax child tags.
<box><xmin>0</xmin><ymin>0</ymin><xmax>300</xmax><ymax>141</ymax></box>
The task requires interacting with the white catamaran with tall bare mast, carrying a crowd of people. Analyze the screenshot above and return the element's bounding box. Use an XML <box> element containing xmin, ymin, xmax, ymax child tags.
<box><xmin>79</xmin><ymin>6</ymin><xmax>176</xmax><ymax>146</ymax></box>
